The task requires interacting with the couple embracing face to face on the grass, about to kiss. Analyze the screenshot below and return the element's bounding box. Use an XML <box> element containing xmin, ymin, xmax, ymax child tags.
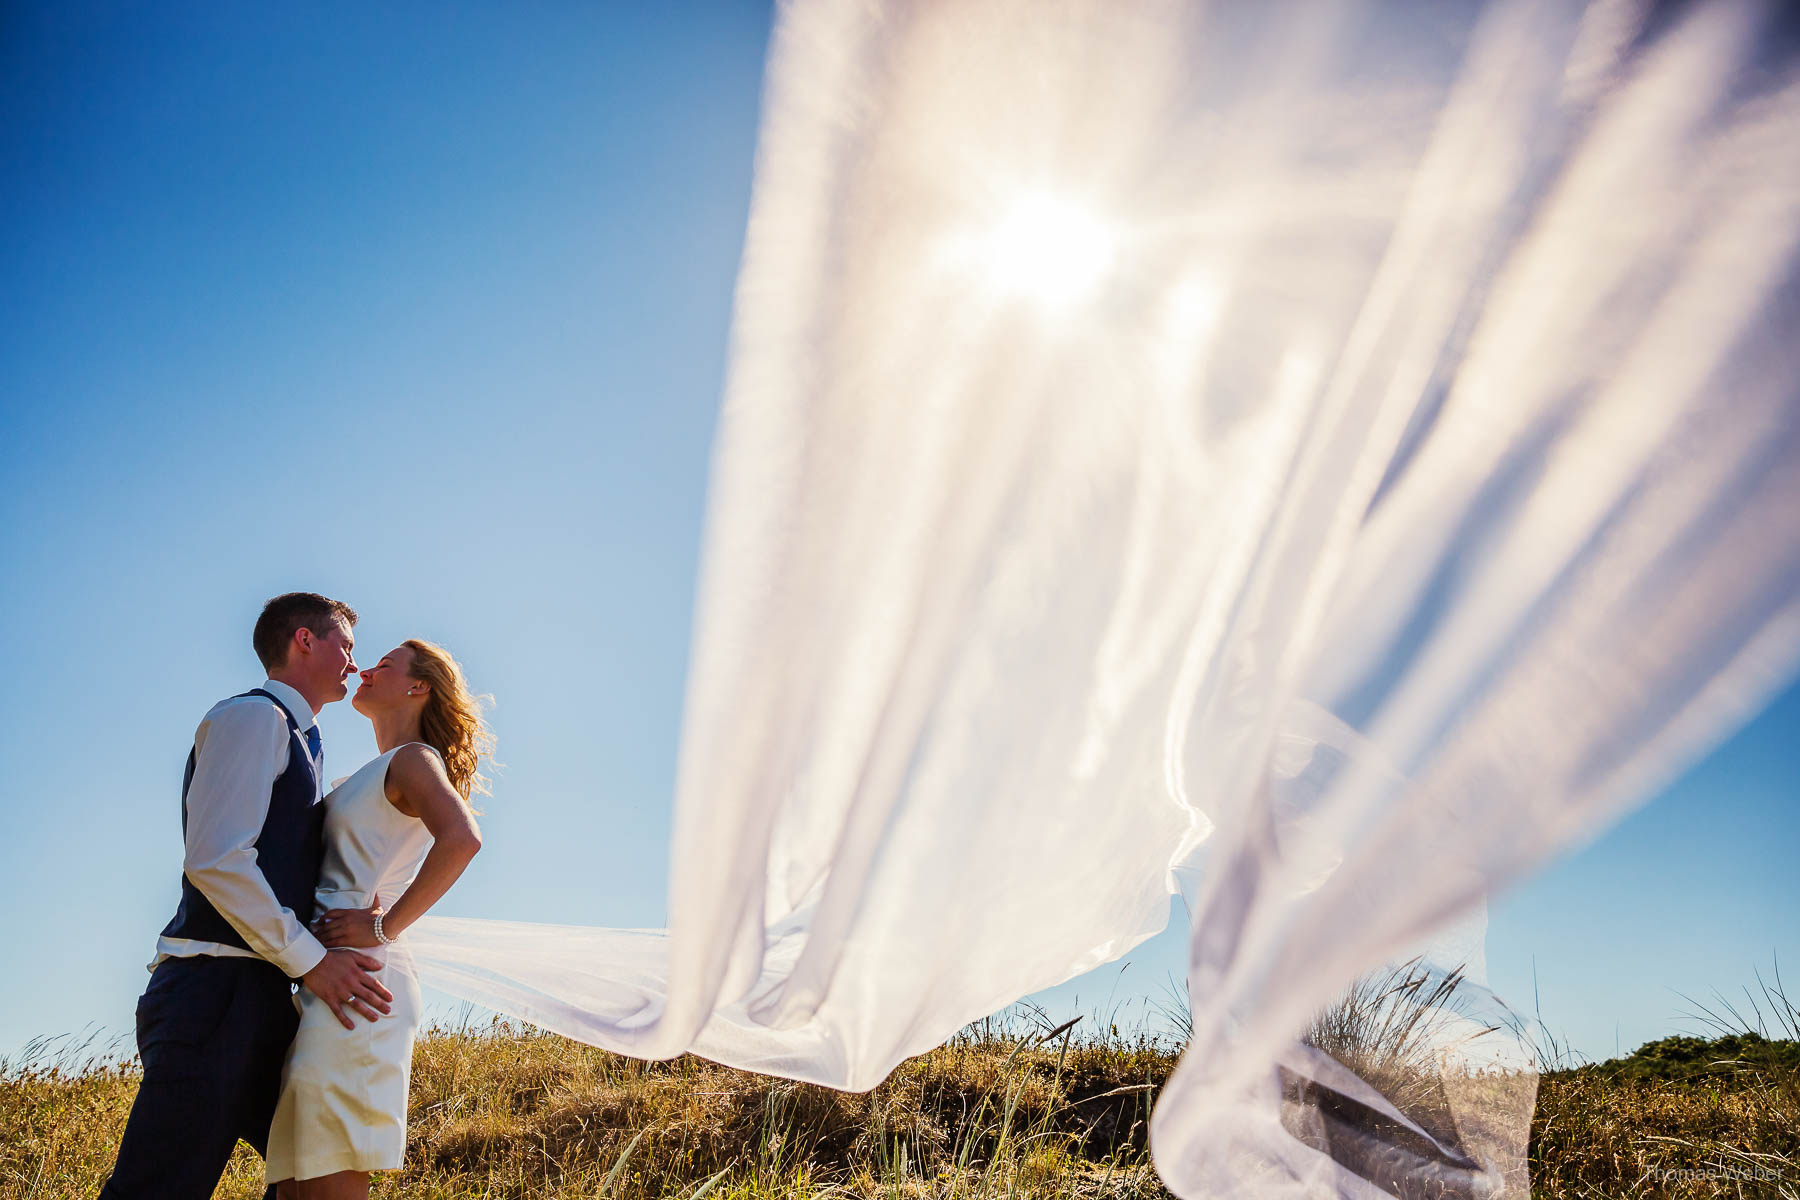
<box><xmin>101</xmin><ymin>592</ymin><xmax>493</xmax><ymax>1200</ymax></box>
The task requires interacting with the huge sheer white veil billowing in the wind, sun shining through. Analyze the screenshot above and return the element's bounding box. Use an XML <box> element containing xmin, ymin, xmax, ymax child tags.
<box><xmin>409</xmin><ymin>0</ymin><xmax>1800</xmax><ymax>1196</ymax></box>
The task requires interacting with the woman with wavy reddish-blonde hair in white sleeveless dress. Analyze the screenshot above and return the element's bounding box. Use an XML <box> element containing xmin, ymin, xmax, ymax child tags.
<box><xmin>266</xmin><ymin>640</ymin><xmax>493</xmax><ymax>1200</ymax></box>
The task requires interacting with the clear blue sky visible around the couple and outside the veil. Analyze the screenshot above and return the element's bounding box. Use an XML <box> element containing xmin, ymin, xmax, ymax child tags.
<box><xmin>0</xmin><ymin>0</ymin><xmax>1800</xmax><ymax>1056</ymax></box>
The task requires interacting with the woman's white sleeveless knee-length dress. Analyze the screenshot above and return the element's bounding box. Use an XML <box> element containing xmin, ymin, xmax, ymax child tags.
<box><xmin>265</xmin><ymin>747</ymin><xmax>432</xmax><ymax>1180</ymax></box>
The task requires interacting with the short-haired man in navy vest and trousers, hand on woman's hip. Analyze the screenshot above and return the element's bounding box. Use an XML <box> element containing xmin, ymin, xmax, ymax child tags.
<box><xmin>101</xmin><ymin>592</ymin><xmax>394</xmax><ymax>1200</ymax></box>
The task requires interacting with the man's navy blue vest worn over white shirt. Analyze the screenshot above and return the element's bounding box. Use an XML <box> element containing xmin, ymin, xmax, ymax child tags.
<box><xmin>162</xmin><ymin>687</ymin><xmax>326</xmax><ymax>971</ymax></box>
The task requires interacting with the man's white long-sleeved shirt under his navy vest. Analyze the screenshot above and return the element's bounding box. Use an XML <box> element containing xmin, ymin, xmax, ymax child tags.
<box><xmin>149</xmin><ymin>680</ymin><xmax>326</xmax><ymax>979</ymax></box>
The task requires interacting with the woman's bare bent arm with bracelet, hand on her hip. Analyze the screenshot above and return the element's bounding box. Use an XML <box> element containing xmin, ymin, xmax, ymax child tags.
<box><xmin>319</xmin><ymin>745</ymin><xmax>481</xmax><ymax>948</ymax></box>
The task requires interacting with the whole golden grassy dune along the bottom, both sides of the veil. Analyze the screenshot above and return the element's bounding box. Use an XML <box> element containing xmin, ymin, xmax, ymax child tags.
<box><xmin>0</xmin><ymin>1025</ymin><xmax>1800</xmax><ymax>1200</ymax></box>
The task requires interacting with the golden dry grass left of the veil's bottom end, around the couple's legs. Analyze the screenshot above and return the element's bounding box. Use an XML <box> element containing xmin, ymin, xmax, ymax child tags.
<box><xmin>0</xmin><ymin>1022</ymin><xmax>1175</xmax><ymax>1200</ymax></box>
